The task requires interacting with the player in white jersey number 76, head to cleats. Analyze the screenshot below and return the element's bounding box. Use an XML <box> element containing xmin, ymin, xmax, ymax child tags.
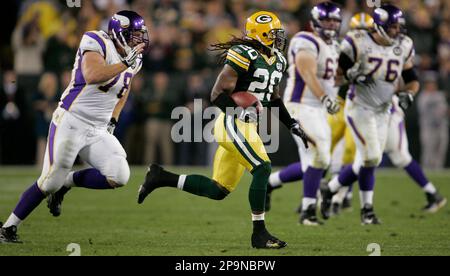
<box><xmin>321</xmin><ymin>4</ymin><xmax>419</xmax><ymax>224</ymax></box>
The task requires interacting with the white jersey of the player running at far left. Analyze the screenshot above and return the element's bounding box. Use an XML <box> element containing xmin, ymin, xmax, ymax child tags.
<box><xmin>59</xmin><ymin>31</ymin><xmax>142</xmax><ymax>126</ymax></box>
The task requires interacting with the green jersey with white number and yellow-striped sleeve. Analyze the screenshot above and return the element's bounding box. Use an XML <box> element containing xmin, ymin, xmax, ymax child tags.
<box><xmin>225</xmin><ymin>44</ymin><xmax>287</xmax><ymax>106</ymax></box>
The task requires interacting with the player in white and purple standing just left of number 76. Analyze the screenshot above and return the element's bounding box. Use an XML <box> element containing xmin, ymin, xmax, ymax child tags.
<box><xmin>284</xmin><ymin>2</ymin><xmax>341</xmax><ymax>225</ymax></box>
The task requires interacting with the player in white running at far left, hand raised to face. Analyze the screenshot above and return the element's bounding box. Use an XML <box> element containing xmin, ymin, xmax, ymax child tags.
<box><xmin>0</xmin><ymin>11</ymin><xmax>149</xmax><ymax>243</ymax></box>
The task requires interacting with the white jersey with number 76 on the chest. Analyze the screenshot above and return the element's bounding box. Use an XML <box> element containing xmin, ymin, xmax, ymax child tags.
<box><xmin>341</xmin><ymin>30</ymin><xmax>414</xmax><ymax>111</ymax></box>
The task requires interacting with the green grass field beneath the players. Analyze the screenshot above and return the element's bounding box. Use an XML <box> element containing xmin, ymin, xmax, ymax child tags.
<box><xmin>0</xmin><ymin>167</ymin><xmax>450</xmax><ymax>256</ymax></box>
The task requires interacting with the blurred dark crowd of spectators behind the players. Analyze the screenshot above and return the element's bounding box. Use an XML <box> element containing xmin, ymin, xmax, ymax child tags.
<box><xmin>0</xmin><ymin>0</ymin><xmax>450</xmax><ymax>169</ymax></box>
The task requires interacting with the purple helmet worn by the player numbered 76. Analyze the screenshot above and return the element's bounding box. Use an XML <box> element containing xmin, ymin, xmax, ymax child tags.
<box><xmin>372</xmin><ymin>4</ymin><xmax>405</xmax><ymax>45</ymax></box>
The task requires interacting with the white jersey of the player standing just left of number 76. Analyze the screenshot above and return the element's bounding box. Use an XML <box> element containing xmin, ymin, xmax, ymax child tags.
<box><xmin>283</xmin><ymin>32</ymin><xmax>339</xmax><ymax>106</ymax></box>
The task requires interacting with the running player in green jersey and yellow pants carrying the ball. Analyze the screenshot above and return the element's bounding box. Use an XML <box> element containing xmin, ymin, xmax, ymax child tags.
<box><xmin>138</xmin><ymin>11</ymin><xmax>309</xmax><ymax>248</ymax></box>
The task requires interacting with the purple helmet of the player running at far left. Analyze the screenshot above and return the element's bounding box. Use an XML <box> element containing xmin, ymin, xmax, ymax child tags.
<box><xmin>108</xmin><ymin>10</ymin><xmax>149</xmax><ymax>52</ymax></box>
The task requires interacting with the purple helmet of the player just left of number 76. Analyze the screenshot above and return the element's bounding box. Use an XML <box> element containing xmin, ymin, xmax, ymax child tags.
<box><xmin>311</xmin><ymin>2</ymin><xmax>342</xmax><ymax>39</ymax></box>
